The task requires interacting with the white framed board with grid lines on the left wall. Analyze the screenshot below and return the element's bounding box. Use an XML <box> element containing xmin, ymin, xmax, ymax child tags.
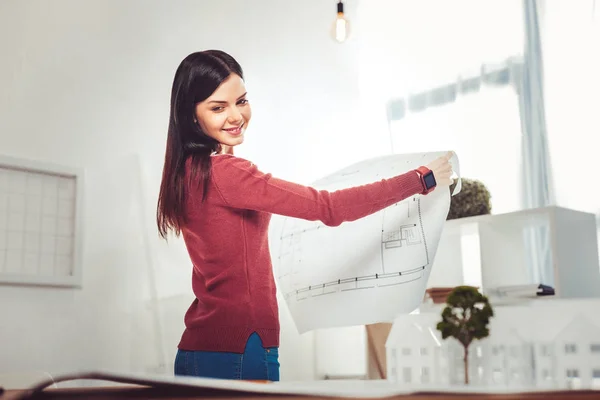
<box><xmin>0</xmin><ymin>156</ymin><xmax>83</xmax><ymax>287</ymax></box>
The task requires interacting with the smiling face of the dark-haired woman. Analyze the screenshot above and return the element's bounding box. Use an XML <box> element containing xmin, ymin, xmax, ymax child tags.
<box><xmin>196</xmin><ymin>74</ymin><xmax>252</xmax><ymax>146</ymax></box>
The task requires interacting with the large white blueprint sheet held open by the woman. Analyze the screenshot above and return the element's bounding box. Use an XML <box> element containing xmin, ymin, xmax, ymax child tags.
<box><xmin>271</xmin><ymin>152</ymin><xmax>460</xmax><ymax>333</ymax></box>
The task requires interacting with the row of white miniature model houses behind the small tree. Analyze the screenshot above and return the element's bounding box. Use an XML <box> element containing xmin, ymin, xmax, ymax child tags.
<box><xmin>386</xmin><ymin>299</ymin><xmax>600</xmax><ymax>389</ymax></box>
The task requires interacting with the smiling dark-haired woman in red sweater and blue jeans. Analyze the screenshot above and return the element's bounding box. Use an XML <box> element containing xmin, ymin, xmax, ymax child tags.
<box><xmin>157</xmin><ymin>50</ymin><xmax>452</xmax><ymax>381</ymax></box>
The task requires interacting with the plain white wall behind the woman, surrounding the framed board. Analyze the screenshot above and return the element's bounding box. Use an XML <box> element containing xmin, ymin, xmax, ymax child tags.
<box><xmin>0</xmin><ymin>0</ymin><xmax>387</xmax><ymax>379</ymax></box>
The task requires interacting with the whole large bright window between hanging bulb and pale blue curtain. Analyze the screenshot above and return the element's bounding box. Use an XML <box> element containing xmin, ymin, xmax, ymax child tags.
<box><xmin>359</xmin><ymin>0</ymin><xmax>524</xmax><ymax>217</ymax></box>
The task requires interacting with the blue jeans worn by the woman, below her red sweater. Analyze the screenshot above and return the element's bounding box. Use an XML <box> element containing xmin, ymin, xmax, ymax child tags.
<box><xmin>175</xmin><ymin>333</ymin><xmax>279</xmax><ymax>381</ymax></box>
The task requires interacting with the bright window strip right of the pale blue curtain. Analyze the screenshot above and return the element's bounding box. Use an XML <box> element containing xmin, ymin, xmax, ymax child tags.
<box><xmin>542</xmin><ymin>0</ymin><xmax>600</xmax><ymax>222</ymax></box>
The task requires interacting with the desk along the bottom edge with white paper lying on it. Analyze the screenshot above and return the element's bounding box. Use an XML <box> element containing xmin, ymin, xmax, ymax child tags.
<box><xmin>0</xmin><ymin>372</ymin><xmax>600</xmax><ymax>400</ymax></box>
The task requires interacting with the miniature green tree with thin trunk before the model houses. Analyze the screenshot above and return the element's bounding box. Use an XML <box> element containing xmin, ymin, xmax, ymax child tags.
<box><xmin>436</xmin><ymin>286</ymin><xmax>494</xmax><ymax>384</ymax></box>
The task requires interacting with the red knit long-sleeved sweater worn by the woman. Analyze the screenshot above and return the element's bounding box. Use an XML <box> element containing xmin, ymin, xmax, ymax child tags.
<box><xmin>179</xmin><ymin>155</ymin><xmax>423</xmax><ymax>353</ymax></box>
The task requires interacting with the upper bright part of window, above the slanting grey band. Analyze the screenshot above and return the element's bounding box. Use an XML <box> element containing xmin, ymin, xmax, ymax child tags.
<box><xmin>357</xmin><ymin>0</ymin><xmax>524</xmax><ymax>96</ymax></box>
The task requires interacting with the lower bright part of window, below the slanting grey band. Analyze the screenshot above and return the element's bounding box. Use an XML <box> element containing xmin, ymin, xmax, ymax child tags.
<box><xmin>390</xmin><ymin>87</ymin><xmax>521</xmax><ymax>217</ymax></box>
